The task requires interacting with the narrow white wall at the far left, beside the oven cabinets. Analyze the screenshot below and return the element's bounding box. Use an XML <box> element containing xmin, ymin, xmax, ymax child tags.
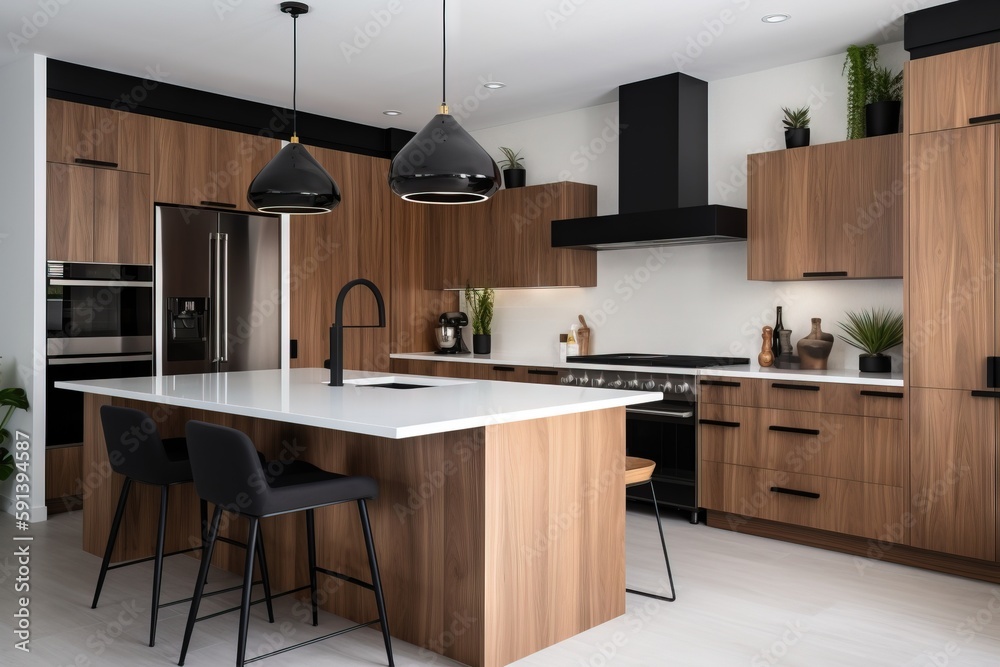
<box><xmin>0</xmin><ymin>55</ymin><xmax>46</xmax><ymax>521</ymax></box>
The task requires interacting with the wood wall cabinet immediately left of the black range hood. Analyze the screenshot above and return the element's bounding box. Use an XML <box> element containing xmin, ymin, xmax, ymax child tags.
<box><xmin>422</xmin><ymin>182</ymin><xmax>597</xmax><ymax>289</ymax></box>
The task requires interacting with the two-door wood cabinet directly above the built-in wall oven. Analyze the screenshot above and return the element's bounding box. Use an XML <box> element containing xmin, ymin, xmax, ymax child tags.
<box><xmin>46</xmin><ymin>162</ymin><xmax>153</xmax><ymax>264</ymax></box>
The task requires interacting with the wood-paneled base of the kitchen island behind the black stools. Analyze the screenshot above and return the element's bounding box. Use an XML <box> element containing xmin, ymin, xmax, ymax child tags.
<box><xmin>83</xmin><ymin>393</ymin><xmax>625</xmax><ymax>667</ymax></box>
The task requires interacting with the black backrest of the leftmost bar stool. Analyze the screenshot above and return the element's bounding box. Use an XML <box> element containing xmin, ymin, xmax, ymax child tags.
<box><xmin>101</xmin><ymin>405</ymin><xmax>183</xmax><ymax>484</ymax></box>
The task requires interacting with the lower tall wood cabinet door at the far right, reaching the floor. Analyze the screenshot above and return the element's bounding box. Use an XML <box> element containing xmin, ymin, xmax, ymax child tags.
<box><xmin>910</xmin><ymin>388</ymin><xmax>998</xmax><ymax>560</ymax></box>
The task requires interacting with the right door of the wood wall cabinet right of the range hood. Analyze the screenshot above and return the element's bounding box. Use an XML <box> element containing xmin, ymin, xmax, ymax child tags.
<box><xmin>824</xmin><ymin>134</ymin><xmax>905</xmax><ymax>278</ymax></box>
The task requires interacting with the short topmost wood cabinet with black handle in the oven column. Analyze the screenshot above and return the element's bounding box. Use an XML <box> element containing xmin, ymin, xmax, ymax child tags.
<box><xmin>46</xmin><ymin>99</ymin><xmax>151</xmax><ymax>174</ymax></box>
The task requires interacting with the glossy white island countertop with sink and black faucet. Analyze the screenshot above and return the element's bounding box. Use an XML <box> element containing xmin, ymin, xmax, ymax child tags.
<box><xmin>55</xmin><ymin>368</ymin><xmax>662</xmax><ymax>439</ymax></box>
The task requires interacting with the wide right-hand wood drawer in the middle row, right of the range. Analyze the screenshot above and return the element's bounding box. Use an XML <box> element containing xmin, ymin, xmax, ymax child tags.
<box><xmin>757</xmin><ymin>410</ymin><xmax>903</xmax><ymax>486</ymax></box>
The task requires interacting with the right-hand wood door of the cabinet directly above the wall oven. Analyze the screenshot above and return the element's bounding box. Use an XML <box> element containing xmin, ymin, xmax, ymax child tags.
<box><xmin>93</xmin><ymin>169</ymin><xmax>153</xmax><ymax>264</ymax></box>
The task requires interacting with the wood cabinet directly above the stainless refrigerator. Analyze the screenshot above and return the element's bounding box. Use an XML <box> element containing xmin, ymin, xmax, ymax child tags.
<box><xmin>152</xmin><ymin>118</ymin><xmax>281</xmax><ymax>211</ymax></box>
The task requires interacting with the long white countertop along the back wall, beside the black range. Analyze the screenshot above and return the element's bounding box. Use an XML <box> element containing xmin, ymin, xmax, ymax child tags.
<box><xmin>389</xmin><ymin>352</ymin><xmax>903</xmax><ymax>387</ymax></box>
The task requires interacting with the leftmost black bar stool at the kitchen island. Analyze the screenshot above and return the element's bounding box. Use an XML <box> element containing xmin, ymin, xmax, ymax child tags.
<box><xmin>91</xmin><ymin>405</ymin><xmax>274</xmax><ymax>646</ymax></box>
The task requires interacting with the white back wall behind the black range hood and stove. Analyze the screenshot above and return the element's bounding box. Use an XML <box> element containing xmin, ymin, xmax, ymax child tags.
<box><xmin>472</xmin><ymin>43</ymin><xmax>906</xmax><ymax>369</ymax></box>
